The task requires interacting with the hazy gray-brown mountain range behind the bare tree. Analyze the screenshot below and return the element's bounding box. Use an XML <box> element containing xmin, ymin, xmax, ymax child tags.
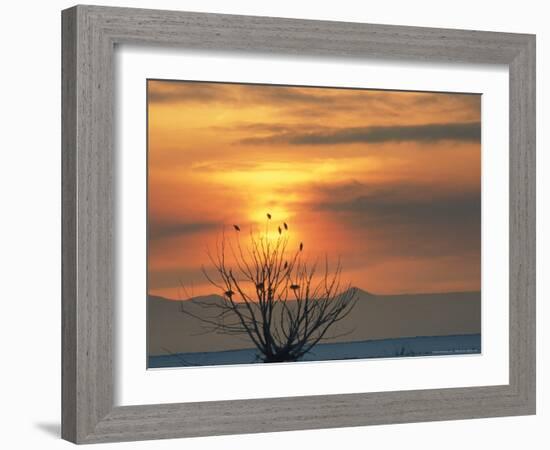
<box><xmin>147</xmin><ymin>289</ymin><xmax>481</xmax><ymax>355</ymax></box>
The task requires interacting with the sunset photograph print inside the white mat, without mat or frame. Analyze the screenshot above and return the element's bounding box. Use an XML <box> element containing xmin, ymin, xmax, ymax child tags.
<box><xmin>147</xmin><ymin>79</ymin><xmax>481</xmax><ymax>368</ymax></box>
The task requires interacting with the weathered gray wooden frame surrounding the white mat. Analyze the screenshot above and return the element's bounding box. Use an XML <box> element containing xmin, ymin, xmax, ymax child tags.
<box><xmin>62</xmin><ymin>6</ymin><xmax>535</xmax><ymax>443</ymax></box>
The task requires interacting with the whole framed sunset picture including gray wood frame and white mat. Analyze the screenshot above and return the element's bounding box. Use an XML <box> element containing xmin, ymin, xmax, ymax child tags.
<box><xmin>62</xmin><ymin>6</ymin><xmax>535</xmax><ymax>443</ymax></box>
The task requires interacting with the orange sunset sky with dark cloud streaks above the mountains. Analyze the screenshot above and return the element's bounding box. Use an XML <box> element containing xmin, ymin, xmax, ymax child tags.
<box><xmin>147</xmin><ymin>80</ymin><xmax>481</xmax><ymax>298</ymax></box>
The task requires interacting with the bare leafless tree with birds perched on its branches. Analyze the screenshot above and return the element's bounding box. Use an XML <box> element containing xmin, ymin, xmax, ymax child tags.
<box><xmin>182</xmin><ymin>214</ymin><xmax>356</xmax><ymax>362</ymax></box>
